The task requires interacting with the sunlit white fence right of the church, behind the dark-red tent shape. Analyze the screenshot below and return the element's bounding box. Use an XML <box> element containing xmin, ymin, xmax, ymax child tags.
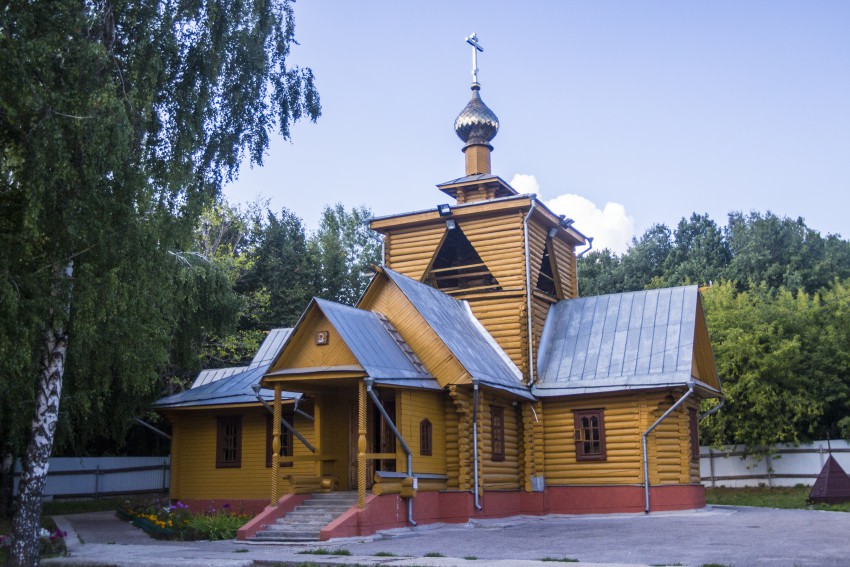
<box><xmin>700</xmin><ymin>440</ymin><xmax>850</xmax><ymax>488</ymax></box>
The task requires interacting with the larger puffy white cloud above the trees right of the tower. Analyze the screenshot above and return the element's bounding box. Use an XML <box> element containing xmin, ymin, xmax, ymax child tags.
<box><xmin>546</xmin><ymin>194</ymin><xmax>635</xmax><ymax>254</ymax></box>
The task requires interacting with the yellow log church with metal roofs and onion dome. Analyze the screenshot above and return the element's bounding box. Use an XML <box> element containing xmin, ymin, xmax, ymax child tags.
<box><xmin>155</xmin><ymin>41</ymin><xmax>722</xmax><ymax>539</ymax></box>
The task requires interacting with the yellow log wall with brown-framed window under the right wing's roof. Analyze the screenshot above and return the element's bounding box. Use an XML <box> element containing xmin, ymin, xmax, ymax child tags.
<box><xmin>542</xmin><ymin>392</ymin><xmax>699</xmax><ymax>485</ymax></box>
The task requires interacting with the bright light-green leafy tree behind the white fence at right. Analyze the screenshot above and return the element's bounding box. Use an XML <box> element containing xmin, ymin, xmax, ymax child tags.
<box><xmin>703</xmin><ymin>282</ymin><xmax>850</xmax><ymax>452</ymax></box>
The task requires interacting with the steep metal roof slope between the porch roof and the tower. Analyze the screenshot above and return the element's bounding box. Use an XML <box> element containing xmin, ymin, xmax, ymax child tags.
<box><xmin>384</xmin><ymin>268</ymin><xmax>533</xmax><ymax>399</ymax></box>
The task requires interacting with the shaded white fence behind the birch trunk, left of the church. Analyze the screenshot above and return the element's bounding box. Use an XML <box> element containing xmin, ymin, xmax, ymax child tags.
<box><xmin>13</xmin><ymin>457</ymin><xmax>171</xmax><ymax>498</ymax></box>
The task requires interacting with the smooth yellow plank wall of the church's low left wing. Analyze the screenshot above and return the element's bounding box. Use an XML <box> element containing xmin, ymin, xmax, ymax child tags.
<box><xmin>168</xmin><ymin>407</ymin><xmax>315</xmax><ymax>500</ymax></box>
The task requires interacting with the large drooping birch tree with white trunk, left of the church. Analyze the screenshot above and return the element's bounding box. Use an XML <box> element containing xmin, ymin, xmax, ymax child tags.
<box><xmin>0</xmin><ymin>0</ymin><xmax>320</xmax><ymax>566</ymax></box>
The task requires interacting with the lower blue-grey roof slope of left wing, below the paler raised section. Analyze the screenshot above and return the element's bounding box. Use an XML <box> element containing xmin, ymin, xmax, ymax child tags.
<box><xmin>153</xmin><ymin>366</ymin><xmax>301</xmax><ymax>409</ymax></box>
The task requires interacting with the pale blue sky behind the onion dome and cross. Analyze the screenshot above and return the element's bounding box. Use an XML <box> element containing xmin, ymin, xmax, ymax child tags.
<box><xmin>225</xmin><ymin>0</ymin><xmax>850</xmax><ymax>253</ymax></box>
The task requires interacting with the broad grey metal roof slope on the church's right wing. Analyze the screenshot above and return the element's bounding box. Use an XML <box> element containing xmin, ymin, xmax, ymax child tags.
<box><xmin>532</xmin><ymin>286</ymin><xmax>709</xmax><ymax>397</ymax></box>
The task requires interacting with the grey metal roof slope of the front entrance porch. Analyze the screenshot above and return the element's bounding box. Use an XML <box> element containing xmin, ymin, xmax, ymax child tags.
<box><xmin>313</xmin><ymin>298</ymin><xmax>440</xmax><ymax>389</ymax></box>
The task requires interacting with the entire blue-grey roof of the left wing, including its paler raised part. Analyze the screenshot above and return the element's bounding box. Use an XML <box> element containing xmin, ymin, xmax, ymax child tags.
<box><xmin>153</xmin><ymin>329</ymin><xmax>300</xmax><ymax>409</ymax></box>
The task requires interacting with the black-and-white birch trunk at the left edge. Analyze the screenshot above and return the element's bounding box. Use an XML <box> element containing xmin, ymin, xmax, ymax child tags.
<box><xmin>9</xmin><ymin>261</ymin><xmax>74</xmax><ymax>567</ymax></box>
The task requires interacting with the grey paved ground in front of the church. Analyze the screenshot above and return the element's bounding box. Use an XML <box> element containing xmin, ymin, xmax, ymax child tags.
<box><xmin>45</xmin><ymin>506</ymin><xmax>850</xmax><ymax>567</ymax></box>
